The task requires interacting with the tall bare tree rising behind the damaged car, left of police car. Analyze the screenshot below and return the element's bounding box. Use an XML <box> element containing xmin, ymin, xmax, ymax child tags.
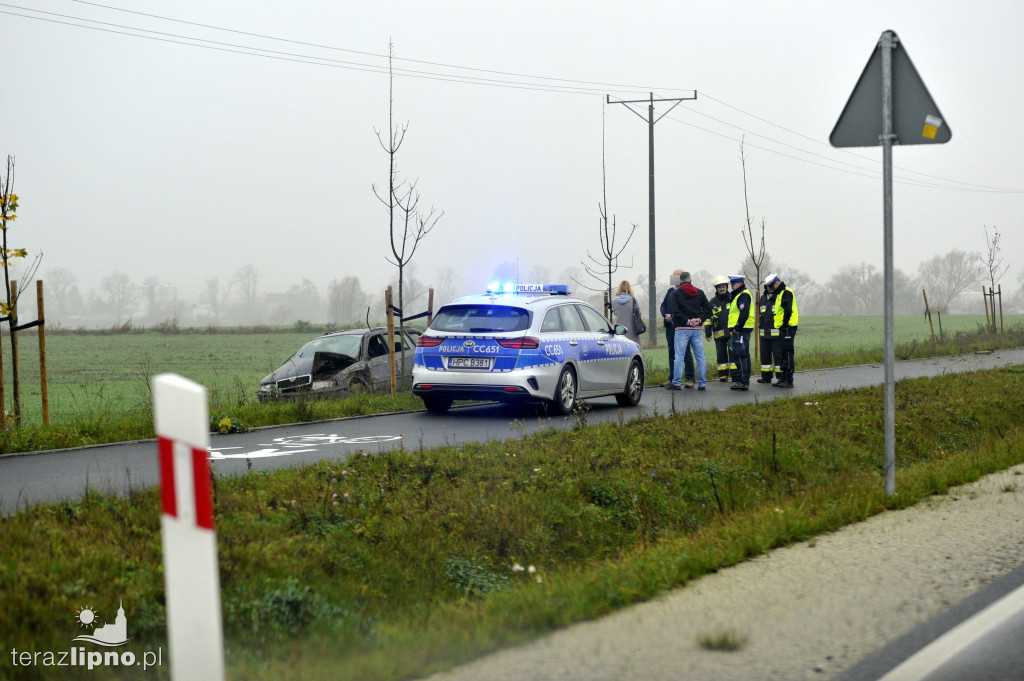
<box><xmin>373</xmin><ymin>42</ymin><xmax>444</xmax><ymax>385</ymax></box>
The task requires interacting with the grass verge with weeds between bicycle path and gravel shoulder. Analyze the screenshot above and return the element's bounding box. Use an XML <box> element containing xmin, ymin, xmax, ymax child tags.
<box><xmin>0</xmin><ymin>368</ymin><xmax>1024</xmax><ymax>681</ymax></box>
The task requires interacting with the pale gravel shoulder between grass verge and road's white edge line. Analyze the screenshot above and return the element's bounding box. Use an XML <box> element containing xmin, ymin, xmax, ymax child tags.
<box><xmin>419</xmin><ymin>465</ymin><xmax>1024</xmax><ymax>681</ymax></box>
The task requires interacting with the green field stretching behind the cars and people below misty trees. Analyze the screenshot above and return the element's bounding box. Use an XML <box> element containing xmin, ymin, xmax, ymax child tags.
<box><xmin>2</xmin><ymin>314</ymin><xmax>1024</xmax><ymax>424</ymax></box>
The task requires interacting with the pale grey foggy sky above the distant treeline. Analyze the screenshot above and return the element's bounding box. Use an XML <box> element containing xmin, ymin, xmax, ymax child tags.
<box><xmin>0</xmin><ymin>0</ymin><xmax>1024</xmax><ymax>298</ymax></box>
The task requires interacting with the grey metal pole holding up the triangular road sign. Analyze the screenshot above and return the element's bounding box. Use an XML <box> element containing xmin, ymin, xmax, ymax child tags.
<box><xmin>879</xmin><ymin>31</ymin><xmax>896</xmax><ymax>497</ymax></box>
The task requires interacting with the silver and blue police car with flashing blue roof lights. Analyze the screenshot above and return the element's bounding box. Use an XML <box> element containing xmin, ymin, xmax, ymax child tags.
<box><xmin>413</xmin><ymin>285</ymin><xmax>644</xmax><ymax>414</ymax></box>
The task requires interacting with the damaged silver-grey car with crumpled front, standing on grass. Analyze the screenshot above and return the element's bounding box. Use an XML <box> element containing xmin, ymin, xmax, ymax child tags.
<box><xmin>257</xmin><ymin>328</ymin><xmax>416</xmax><ymax>401</ymax></box>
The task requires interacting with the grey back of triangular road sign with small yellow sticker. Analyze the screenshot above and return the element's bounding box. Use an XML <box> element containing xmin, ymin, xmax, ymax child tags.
<box><xmin>828</xmin><ymin>32</ymin><xmax>952</xmax><ymax>146</ymax></box>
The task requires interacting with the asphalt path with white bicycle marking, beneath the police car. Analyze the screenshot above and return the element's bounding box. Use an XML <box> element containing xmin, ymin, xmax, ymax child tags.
<box><xmin>0</xmin><ymin>348</ymin><xmax>1024</xmax><ymax>514</ymax></box>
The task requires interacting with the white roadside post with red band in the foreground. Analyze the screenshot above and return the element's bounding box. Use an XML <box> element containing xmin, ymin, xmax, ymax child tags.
<box><xmin>153</xmin><ymin>374</ymin><xmax>224</xmax><ymax>681</ymax></box>
